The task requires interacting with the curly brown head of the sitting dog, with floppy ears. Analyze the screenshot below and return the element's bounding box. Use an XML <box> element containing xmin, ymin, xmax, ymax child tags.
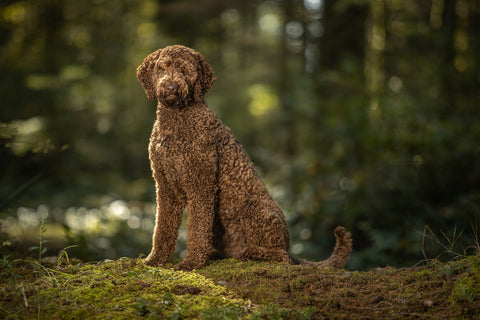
<box><xmin>137</xmin><ymin>45</ymin><xmax>215</xmax><ymax>107</ymax></box>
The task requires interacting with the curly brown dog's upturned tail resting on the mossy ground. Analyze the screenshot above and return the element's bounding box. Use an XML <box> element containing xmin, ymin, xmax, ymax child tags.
<box><xmin>292</xmin><ymin>227</ymin><xmax>352</xmax><ymax>269</ymax></box>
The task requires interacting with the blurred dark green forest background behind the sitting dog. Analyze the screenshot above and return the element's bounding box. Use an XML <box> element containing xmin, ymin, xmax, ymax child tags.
<box><xmin>0</xmin><ymin>0</ymin><xmax>480</xmax><ymax>269</ymax></box>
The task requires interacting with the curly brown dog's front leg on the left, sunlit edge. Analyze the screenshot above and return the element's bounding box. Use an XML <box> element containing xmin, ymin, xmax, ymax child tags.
<box><xmin>145</xmin><ymin>179</ymin><xmax>186</xmax><ymax>266</ymax></box>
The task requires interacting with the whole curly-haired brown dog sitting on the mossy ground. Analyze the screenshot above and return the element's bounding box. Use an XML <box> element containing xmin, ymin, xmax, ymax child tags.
<box><xmin>137</xmin><ymin>45</ymin><xmax>351</xmax><ymax>270</ymax></box>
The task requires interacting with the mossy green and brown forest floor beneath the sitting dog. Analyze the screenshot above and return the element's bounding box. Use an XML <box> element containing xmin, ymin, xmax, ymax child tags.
<box><xmin>0</xmin><ymin>255</ymin><xmax>480</xmax><ymax>319</ymax></box>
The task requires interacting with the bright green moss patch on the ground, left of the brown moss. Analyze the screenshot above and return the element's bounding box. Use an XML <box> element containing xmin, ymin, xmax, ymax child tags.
<box><xmin>0</xmin><ymin>259</ymin><xmax>248</xmax><ymax>319</ymax></box>
